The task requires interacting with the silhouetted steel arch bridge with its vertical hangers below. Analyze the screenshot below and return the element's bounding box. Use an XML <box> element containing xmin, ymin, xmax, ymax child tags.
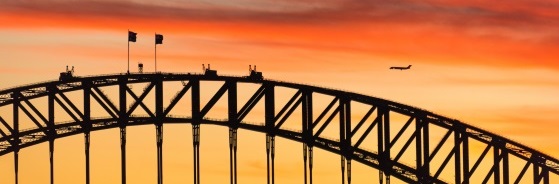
<box><xmin>0</xmin><ymin>73</ymin><xmax>559</xmax><ymax>184</ymax></box>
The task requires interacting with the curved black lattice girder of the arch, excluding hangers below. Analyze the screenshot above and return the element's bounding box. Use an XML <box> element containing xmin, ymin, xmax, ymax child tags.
<box><xmin>0</xmin><ymin>73</ymin><xmax>559</xmax><ymax>183</ymax></box>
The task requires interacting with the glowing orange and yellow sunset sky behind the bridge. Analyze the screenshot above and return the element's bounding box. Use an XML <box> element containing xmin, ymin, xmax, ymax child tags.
<box><xmin>0</xmin><ymin>0</ymin><xmax>559</xmax><ymax>183</ymax></box>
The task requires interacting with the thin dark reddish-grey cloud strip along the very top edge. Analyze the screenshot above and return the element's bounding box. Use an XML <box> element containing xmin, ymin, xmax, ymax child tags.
<box><xmin>0</xmin><ymin>0</ymin><xmax>559</xmax><ymax>27</ymax></box>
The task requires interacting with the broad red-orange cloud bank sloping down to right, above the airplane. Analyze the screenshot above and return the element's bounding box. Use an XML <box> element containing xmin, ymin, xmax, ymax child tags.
<box><xmin>0</xmin><ymin>0</ymin><xmax>559</xmax><ymax>69</ymax></box>
